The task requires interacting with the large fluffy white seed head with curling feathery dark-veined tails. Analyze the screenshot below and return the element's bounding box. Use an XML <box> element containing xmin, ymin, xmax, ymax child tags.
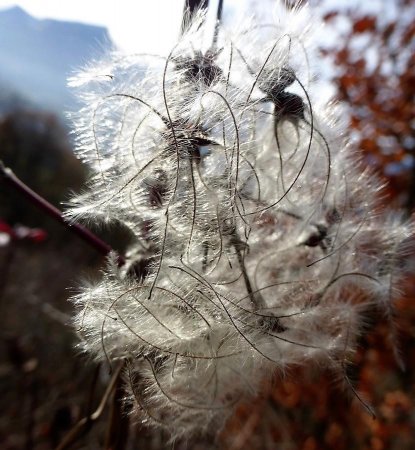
<box><xmin>68</xmin><ymin>1</ymin><xmax>410</xmax><ymax>437</ymax></box>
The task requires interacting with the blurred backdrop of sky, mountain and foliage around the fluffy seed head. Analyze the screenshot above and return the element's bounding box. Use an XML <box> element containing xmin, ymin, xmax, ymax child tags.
<box><xmin>0</xmin><ymin>0</ymin><xmax>415</xmax><ymax>450</ymax></box>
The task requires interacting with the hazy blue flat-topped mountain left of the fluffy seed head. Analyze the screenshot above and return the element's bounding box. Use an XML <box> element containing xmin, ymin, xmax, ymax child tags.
<box><xmin>0</xmin><ymin>6</ymin><xmax>113</xmax><ymax>116</ymax></box>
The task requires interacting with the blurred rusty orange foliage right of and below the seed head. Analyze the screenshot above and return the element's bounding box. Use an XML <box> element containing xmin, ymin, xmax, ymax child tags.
<box><xmin>221</xmin><ymin>0</ymin><xmax>415</xmax><ymax>450</ymax></box>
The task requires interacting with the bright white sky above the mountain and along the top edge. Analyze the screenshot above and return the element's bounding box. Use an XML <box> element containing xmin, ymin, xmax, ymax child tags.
<box><xmin>0</xmin><ymin>0</ymin><xmax>398</xmax><ymax>53</ymax></box>
